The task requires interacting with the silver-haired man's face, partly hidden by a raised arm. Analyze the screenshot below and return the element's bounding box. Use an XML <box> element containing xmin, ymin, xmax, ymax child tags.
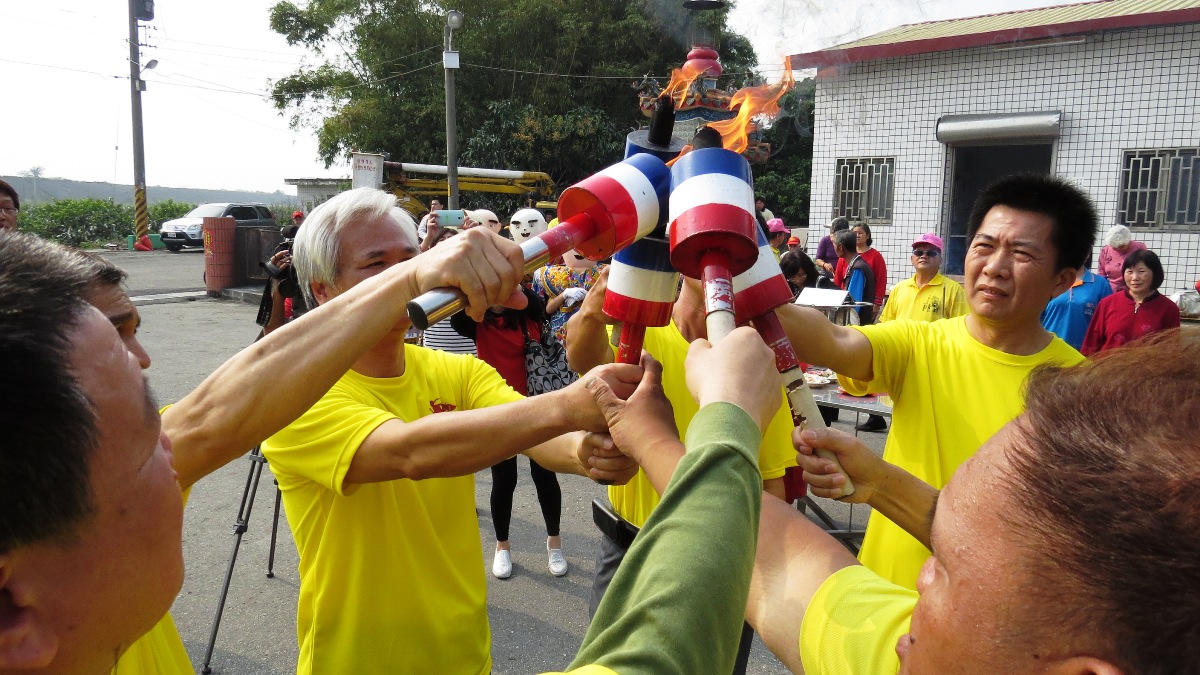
<box><xmin>312</xmin><ymin>215</ymin><xmax>420</xmax><ymax>304</ymax></box>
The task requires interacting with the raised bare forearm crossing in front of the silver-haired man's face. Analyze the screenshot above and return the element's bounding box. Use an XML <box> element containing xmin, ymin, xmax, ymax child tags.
<box><xmin>163</xmin><ymin>263</ymin><xmax>427</xmax><ymax>486</ymax></box>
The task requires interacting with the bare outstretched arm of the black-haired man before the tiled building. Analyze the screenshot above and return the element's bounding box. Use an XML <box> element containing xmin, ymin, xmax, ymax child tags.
<box><xmin>775</xmin><ymin>305</ymin><xmax>871</xmax><ymax>380</ymax></box>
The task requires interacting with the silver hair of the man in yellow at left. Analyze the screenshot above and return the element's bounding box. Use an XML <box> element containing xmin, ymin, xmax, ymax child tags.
<box><xmin>292</xmin><ymin>187</ymin><xmax>416</xmax><ymax>307</ymax></box>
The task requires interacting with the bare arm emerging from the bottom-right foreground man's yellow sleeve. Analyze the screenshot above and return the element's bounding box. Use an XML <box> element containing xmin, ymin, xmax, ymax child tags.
<box><xmin>746</xmin><ymin>495</ymin><xmax>857</xmax><ymax>673</ymax></box>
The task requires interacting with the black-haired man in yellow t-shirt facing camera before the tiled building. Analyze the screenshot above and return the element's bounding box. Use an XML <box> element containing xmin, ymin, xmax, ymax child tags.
<box><xmin>779</xmin><ymin>175</ymin><xmax>1097</xmax><ymax>589</ymax></box>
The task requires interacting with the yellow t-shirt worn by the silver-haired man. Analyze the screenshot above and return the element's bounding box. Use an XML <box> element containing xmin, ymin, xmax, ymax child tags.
<box><xmin>263</xmin><ymin>345</ymin><xmax>521</xmax><ymax>675</ymax></box>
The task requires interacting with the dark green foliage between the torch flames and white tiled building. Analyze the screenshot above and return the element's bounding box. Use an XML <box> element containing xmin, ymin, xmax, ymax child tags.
<box><xmin>754</xmin><ymin>78</ymin><xmax>815</xmax><ymax>227</ymax></box>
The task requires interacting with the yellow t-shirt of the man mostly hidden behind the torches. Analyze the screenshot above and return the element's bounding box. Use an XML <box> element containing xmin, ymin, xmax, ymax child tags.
<box><xmin>608</xmin><ymin>321</ymin><xmax>796</xmax><ymax>527</ymax></box>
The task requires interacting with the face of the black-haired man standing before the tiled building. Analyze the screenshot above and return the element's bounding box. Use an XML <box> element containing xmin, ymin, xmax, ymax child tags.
<box><xmin>964</xmin><ymin>205</ymin><xmax>1075</xmax><ymax>324</ymax></box>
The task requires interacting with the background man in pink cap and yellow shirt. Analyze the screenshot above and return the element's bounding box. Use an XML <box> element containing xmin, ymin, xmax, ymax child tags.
<box><xmin>856</xmin><ymin>232</ymin><xmax>967</xmax><ymax>431</ymax></box>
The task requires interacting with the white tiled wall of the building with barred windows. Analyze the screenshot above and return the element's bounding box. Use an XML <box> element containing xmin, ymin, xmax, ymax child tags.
<box><xmin>809</xmin><ymin>24</ymin><xmax>1200</xmax><ymax>292</ymax></box>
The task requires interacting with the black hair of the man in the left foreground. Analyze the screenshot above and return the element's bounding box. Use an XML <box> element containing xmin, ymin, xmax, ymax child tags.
<box><xmin>0</xmin><ymin>232</ymin><xmax>98</xmax><ymax>552</ymax></box>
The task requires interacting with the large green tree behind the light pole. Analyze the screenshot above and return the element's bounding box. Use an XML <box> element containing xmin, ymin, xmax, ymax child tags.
<box><xmin>271</xmin><ymin>0</ymin><xmax>756</xmax><ymax>178</ymax></box>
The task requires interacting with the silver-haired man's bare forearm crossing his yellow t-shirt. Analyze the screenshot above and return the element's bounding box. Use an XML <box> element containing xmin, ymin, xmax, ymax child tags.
<box><xmin>346</xmin><ymin>392</ymin><xmax>583</xmax><ymax>484</ymax></box>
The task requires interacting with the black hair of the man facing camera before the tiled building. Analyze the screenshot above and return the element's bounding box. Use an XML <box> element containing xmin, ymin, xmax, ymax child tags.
<box><xmin>967</xmin><ymin>173</ymin><xmax>1098</xmax><ymax>271</ymax></box>
